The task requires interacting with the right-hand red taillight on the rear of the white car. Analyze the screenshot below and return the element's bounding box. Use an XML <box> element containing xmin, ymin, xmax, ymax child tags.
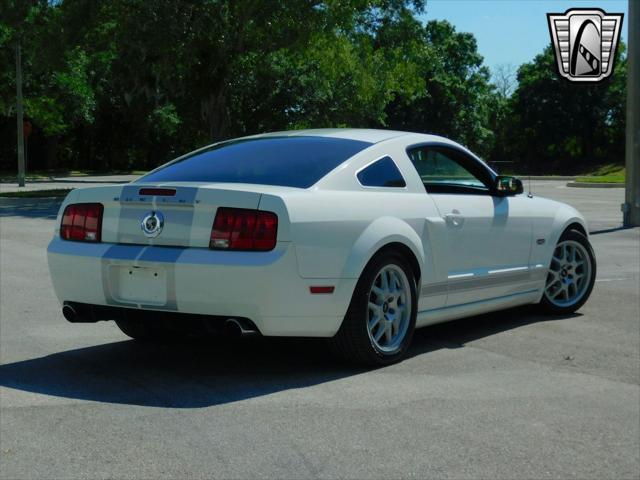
<box><xmin>209</xmin><ymin>207</ymin><xmax>278</xmax><ymax>251</ymax></box>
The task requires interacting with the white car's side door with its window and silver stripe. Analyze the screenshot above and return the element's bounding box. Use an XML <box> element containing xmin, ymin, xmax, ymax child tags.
<box><xmin>408</xmin><ymin>145</ymin><xmax>535</xmax><ymax>306</ymax></box>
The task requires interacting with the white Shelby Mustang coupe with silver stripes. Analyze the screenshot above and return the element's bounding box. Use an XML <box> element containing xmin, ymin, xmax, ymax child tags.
<box><xmin>48</xmin><ymin>129</ymin><xmax>596</xmax><ymax>365</ymax></box>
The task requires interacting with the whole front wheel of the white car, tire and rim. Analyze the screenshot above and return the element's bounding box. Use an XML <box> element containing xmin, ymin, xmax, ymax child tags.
<box><xmin>540</xmin><ymin>230</ymin><xmax>596</xmax><ymax>314</ymax></box>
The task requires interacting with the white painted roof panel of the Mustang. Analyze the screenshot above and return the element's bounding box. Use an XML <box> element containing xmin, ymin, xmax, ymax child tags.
<box><xmin>245</xmin><ymin>128</ymin><xmax>451</xmax><ymax>144</ymax></box>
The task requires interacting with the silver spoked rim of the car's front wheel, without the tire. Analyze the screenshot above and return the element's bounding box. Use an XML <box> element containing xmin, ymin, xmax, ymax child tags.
<box><xmin>545</xmin><ymin>240</ymin><xmax>593</xmax><ymax>307</ymax></box>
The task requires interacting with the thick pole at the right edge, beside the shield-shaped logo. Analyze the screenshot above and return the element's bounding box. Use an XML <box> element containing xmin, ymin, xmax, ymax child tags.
<box><xmin>622</xmin><ymin>0</ymin><xmax>640</xmax><ymax>227</ymax></box>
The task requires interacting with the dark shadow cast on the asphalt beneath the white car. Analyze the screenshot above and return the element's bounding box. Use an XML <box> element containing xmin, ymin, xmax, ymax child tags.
<box><xmin>0</xmin><ymin>308</ymin><xmax>576</xmax><ymax>408</ymax></box>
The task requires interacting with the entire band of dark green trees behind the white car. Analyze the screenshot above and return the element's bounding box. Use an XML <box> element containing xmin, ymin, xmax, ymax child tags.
<box><xmin>0</xmin><ymin>0</ymin><xmax>625</xmax><ymax>171</ymax></box>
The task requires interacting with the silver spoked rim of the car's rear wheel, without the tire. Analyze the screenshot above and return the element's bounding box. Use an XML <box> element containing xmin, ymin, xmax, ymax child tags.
<box><xmin>367</xmin><ymin>265</ymin><xmax>411</xmax><ymax>354</ymax></box>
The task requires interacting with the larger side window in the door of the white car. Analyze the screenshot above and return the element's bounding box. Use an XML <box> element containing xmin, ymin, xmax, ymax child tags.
<box><xmin>408</xmin><ymin>147</ymin><xmax>491</xmax><ymax>194</ymax></box>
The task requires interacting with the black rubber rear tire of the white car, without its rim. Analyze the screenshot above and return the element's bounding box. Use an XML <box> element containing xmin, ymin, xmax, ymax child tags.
<box><xmin>329</xmin><ymin>251</ymin><xmax>418</xmax><ymax>366</ymax></box>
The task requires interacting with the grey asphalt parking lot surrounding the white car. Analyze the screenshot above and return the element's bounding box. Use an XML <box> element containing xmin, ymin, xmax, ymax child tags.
<box><xmin>0</xmin><ymin>182</ymin><xmax>640</xmax><ymax>479</ymax></box>
